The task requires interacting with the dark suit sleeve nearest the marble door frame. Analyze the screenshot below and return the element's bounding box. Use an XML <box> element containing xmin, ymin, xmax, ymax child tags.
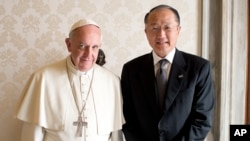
<box><xmin>184</xmin><ymin>62</ymin><xmax>214</xmax><ymax>141</ymax></box>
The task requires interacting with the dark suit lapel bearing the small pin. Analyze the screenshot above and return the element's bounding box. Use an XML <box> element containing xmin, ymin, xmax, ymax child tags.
<box><xmin>165</xmin><ymin>49</ymin><xmax>186</xmax><ymax>111</ymax></box>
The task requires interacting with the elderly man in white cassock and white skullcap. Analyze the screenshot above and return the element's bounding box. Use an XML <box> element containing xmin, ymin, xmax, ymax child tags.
<box><xmin>16</xmin><ymin>19</ymin><xmax>124</xmax><ymax>141</ymax></box>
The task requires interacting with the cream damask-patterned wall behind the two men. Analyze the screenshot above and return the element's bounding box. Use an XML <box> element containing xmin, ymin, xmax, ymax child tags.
<box><xmin>0</xmin><ymin>0</ymin><xmax>201</xmax><ymax>141</ymax></box>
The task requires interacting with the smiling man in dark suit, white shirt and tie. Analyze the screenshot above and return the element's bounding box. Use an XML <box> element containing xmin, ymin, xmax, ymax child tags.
<box><xmin>121</xmin><ymin>5</ymin><xmax>214</xmax><ymax>141</ymax></box>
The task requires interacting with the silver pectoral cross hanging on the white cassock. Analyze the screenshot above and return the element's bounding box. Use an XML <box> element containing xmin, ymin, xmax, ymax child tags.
<box><xmin>73</xmin><ymin>116</ymin><xmax>88</xmax><ymax>140</ymax></box>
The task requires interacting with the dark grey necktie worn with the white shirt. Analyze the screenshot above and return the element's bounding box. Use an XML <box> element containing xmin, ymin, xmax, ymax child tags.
<box><xmin>156</xmin><ymin>59</ymin><xmax>168</xmax><ymax>110</ymax></box>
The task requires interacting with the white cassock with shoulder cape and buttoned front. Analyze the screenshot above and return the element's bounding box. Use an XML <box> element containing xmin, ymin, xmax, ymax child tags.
<box><xmin>16</xmin><ymin>56</ymin><xmax>124</xmax><ymax>141</ymax></box>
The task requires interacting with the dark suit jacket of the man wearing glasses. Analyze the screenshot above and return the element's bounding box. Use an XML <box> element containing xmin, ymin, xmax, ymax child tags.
<box><xmin>121</xmin><ymin>49</ymin><xmax>214</xmax><ymax>141</ymax></box>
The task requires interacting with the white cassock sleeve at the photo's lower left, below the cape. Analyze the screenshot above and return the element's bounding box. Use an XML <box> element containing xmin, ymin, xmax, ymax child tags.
<box><xmin>21</xmin><ymin>122</ymin><xmax>44</xmax><ymax>141</ymax></box>
